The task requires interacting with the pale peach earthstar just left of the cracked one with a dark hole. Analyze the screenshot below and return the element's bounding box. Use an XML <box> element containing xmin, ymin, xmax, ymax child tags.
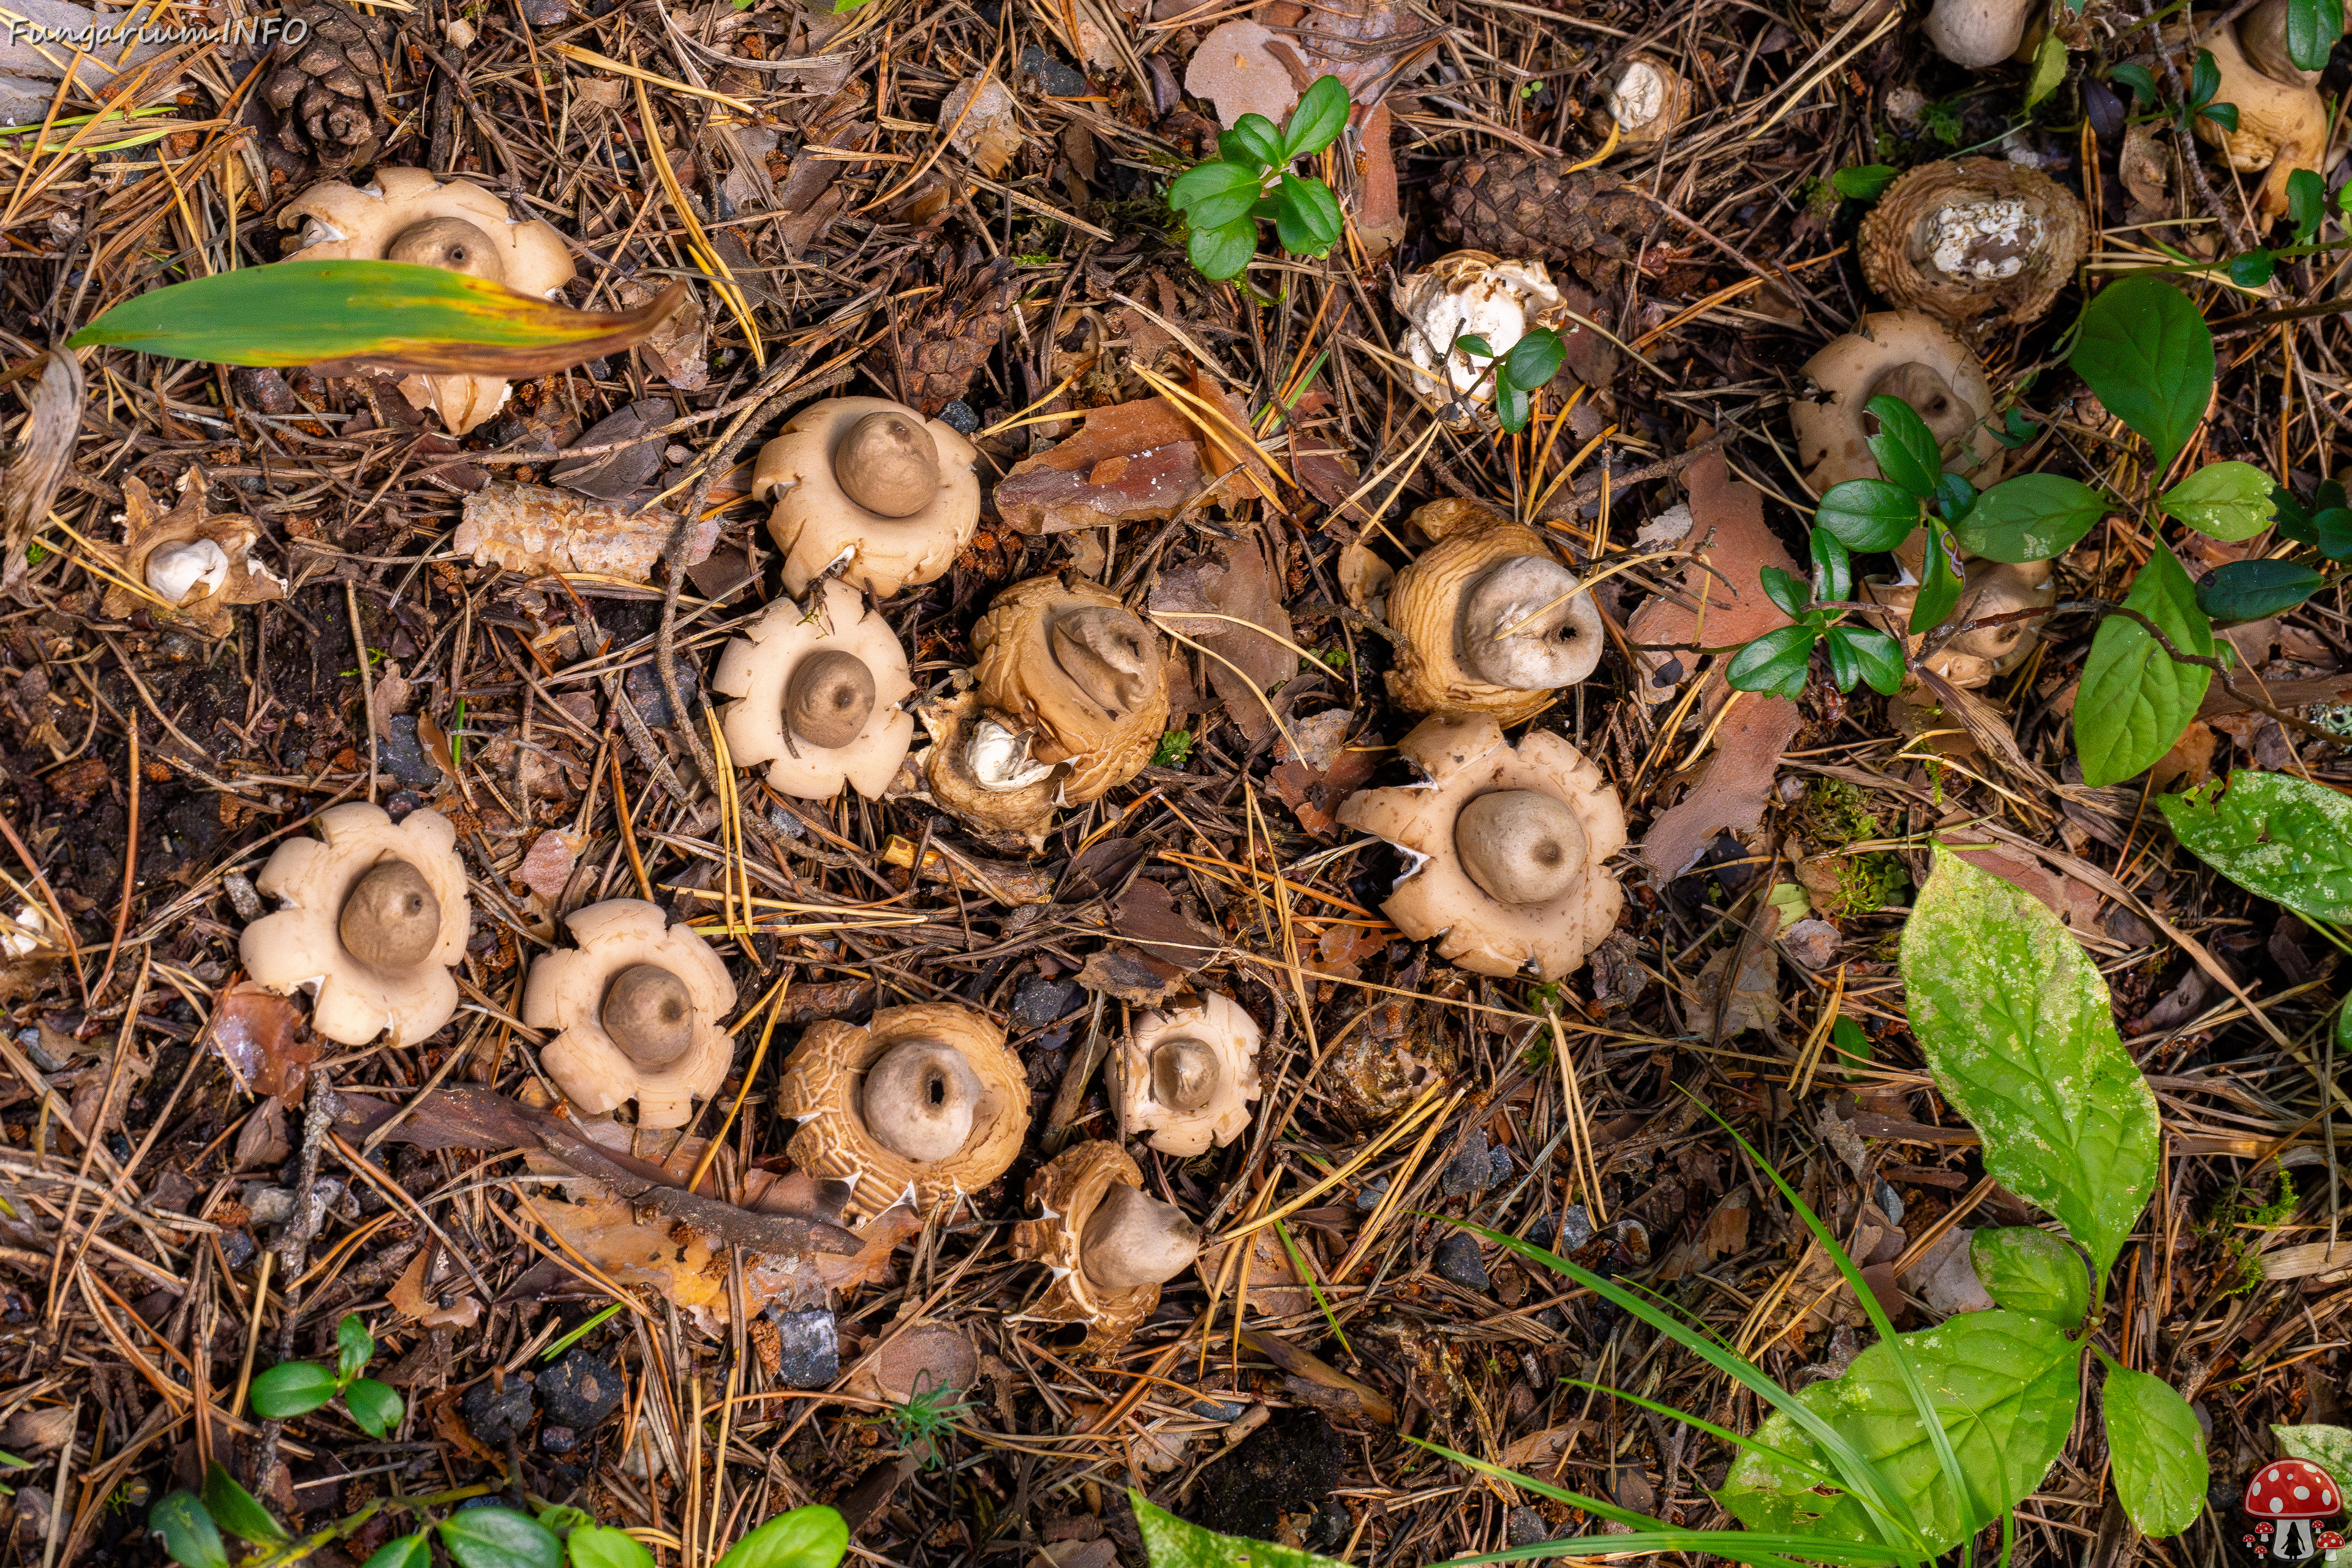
<box><xmin>522</xmin><ymin>898</ymin><xmax>736</xmax><ymax>1128</ymax></box>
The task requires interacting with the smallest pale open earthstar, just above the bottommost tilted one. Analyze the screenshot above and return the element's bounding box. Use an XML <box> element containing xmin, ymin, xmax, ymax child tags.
<box><xmin>1108</xmin><ymin>992</ymin><xmax>1258</xmax><ymax>1159</ymax></box>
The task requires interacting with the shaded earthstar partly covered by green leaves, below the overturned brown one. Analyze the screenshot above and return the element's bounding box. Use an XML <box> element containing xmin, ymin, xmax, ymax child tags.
<box><xmin>1787</xmin><ymin>311</ymin><xmax>2007</xmax><ymax>496</ymax></box>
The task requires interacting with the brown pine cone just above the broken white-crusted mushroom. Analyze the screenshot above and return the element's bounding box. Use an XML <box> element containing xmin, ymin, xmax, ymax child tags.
<box><xmin>1437</xmin><ymin>153</ymin><xmax>1658</xmax><ymax>289</ymax></box>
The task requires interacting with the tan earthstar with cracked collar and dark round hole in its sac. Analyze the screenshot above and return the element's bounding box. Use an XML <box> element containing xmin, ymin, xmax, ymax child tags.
<box><xmin>776</xmin><ymin>1001</ymin><xmax>1028</xmax><ymax>1218</ymax></box>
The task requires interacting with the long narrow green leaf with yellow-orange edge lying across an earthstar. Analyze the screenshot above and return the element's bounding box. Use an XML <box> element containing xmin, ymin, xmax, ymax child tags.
<box><xmin>68</xmin><ymin>256</ymin><xmax>687</xmax><ymax>376</ymax></box>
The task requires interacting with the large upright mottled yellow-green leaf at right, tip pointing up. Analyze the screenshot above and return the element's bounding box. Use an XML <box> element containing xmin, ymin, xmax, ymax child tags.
<box><xmin>1903</xmin><ymin>844</ymin><xmax>2157</xmax><ymax>1279</ymax></box>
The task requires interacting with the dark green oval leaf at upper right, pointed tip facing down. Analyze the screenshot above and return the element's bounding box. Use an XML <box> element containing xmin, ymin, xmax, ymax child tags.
<box><xmin>2067</xmin><ymin>276</ymin><xmax>2213</xmax><ymax>472</ymax></box>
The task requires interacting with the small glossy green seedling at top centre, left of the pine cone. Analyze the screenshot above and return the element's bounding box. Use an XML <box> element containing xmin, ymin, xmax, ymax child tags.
<box><xmin>1169</xmin><ymin>75</ymin><xmax>1348</xmax><ymax>280</ymax></box>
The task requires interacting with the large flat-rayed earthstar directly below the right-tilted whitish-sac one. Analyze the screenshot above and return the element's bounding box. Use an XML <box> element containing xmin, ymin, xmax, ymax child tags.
<box><xmin>1338</xmin><ymin>715</ymin><xmax>1625</xmax><ymax>980</ymax></box>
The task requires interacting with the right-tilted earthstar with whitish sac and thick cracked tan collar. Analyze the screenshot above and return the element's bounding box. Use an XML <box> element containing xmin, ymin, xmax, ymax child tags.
<box><xmin>1388</xmin><ymin>501</ymin><xmax>1604</xmax><ymax>724</ymax></box>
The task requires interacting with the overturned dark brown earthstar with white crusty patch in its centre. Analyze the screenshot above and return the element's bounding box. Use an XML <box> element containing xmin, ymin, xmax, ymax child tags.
<box><xmin>1860</xmin><ymin>157</ymin><xmax>2091</xmax><ymax>326</ymax></box>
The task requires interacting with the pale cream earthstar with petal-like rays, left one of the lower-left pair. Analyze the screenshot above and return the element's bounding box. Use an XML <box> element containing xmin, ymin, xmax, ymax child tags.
<box><xmin>238</xmin><ymin>802</ymin><xmax>473</xmax><ymax>1046</ymax></box>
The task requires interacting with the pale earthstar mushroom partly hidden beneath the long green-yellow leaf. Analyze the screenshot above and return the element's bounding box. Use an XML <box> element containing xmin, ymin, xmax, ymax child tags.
<box><xmin>277</xmin><ymin>169</ymin><xmax>574</xmax><ymax>435</ymax></box>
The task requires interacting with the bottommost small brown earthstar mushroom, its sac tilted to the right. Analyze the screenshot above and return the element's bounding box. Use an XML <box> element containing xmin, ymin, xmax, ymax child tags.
<box><xmin>1014</xmin><ymin>1140</ymin><xmax>1199</xmax><ymax>1354</ymax></box>
